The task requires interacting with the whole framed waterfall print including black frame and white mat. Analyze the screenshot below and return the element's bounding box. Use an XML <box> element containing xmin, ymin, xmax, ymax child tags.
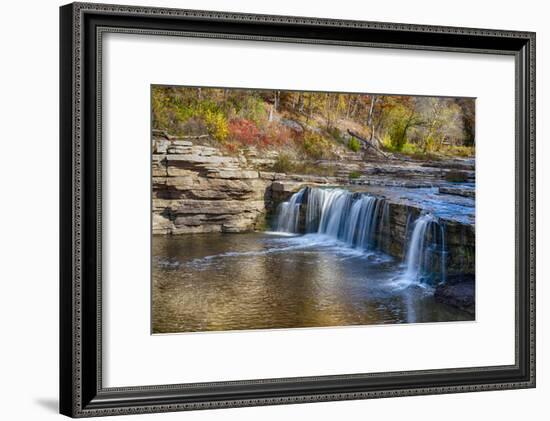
<box><xmin>60</xmin><ymin>3</ymin><xmax>535</xmax><ymax>417</ymax></box>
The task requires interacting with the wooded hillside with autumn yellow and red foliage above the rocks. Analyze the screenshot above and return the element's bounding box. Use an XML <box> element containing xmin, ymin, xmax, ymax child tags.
<box><xmin>152</xmin><ymin>86</ymin><xmax>475</xmax><ymax>159</ymax></box>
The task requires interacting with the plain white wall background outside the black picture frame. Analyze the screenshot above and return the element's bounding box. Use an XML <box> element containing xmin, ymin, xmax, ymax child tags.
<box><xmin>0</xmin><ymin>0</ymin><xmax>550</xmax><ymax>421</ymax></box>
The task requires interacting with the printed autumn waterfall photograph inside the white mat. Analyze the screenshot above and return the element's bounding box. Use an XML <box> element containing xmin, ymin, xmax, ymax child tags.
<box><xmin>150</xmin><ymin>85</ymin><xmax>476</xmax><ymax>334</ymax></box>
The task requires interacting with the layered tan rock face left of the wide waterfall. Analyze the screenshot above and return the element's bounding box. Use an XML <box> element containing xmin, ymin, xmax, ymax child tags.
<box><xmin>152</xmin><ymin>137</ymin><xmax>271</xmax><ymax>234</ymax></box>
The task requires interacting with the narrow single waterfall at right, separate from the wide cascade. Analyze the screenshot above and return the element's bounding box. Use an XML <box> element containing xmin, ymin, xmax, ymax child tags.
<box><xmin>405</xmin><ymin>213</ymin><xmax>447</xmax><ymax>283</ymax></box>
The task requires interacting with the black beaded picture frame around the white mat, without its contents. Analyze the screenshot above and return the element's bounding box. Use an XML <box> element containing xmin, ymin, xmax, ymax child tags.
<box><xmin>60</xmin><ymin>3</ymin><xmax>535</xmax><ymax>417</ymax></box>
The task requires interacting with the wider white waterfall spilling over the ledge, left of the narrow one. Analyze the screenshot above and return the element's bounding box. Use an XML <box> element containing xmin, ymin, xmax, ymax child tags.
<box><xmin>276</xmin><ymin>187</ymin><xmax>389</xmax><ymax>250</ymax></box>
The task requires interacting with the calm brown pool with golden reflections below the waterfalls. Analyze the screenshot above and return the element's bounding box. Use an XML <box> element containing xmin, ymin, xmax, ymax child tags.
<box><xmin>152</xmin><ymin>233</ymin><xmax>473</xmax><ymax>333</ymax></box>
